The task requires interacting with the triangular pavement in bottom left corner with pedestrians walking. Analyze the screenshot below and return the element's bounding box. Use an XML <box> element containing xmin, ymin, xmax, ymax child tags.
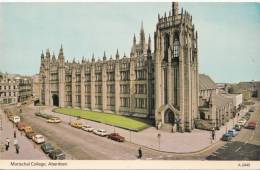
<box><xmin>0</xmin><ymin>108</ymin><xmax>49</xmax><ymax>160</ymax></box>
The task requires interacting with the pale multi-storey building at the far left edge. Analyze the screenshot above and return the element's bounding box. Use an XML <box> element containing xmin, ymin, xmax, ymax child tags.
<box><xmin>0</xmin><ymin>73</ymin><xmax>32</xmax><ymax>104</ymax></box>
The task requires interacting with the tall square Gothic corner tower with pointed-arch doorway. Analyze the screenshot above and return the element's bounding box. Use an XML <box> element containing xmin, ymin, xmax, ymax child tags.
<box><xmin>154</xmin><ymin>2</ymin><xmax>198</xmax><ymax>132</ymax></box>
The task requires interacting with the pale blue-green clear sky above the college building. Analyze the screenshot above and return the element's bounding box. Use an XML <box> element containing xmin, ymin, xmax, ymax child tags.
<box><xmin>0</xmin><ymin>2</ymin><xmax>260</xmax><ymax>82</ymax></box>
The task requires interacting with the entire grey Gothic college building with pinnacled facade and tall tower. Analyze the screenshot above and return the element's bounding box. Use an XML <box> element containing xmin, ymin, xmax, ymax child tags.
<box><xmin>40</xmin><ymin>2</ymin><xmax>199</xmax><ymax>132</ymax></box>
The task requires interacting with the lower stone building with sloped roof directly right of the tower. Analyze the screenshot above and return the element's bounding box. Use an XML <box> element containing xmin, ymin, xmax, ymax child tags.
<box><xmin>195</xmin><ymin>74</ymin><xmax>234</xmax><ymax>130</ymax></box>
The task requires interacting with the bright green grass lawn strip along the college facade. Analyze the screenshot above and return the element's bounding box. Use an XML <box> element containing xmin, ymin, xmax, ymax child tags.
<box><xmin>53</xmin><ymin>108</ymin><xmax>150</xmax><ymax>131</ymax></box>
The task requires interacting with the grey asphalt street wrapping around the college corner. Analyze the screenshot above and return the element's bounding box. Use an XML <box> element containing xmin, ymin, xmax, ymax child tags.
<box><xmin>0</xmin><ymin>101</ymin><xmax>260</xmax><ymax>160</ymax></box>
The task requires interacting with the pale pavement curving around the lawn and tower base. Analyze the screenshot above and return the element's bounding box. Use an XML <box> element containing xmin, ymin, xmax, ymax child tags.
<box><xmin>37</xmin><ymin>105</ymin><xmax>246</xmax><ymax>153</ymax></box>
